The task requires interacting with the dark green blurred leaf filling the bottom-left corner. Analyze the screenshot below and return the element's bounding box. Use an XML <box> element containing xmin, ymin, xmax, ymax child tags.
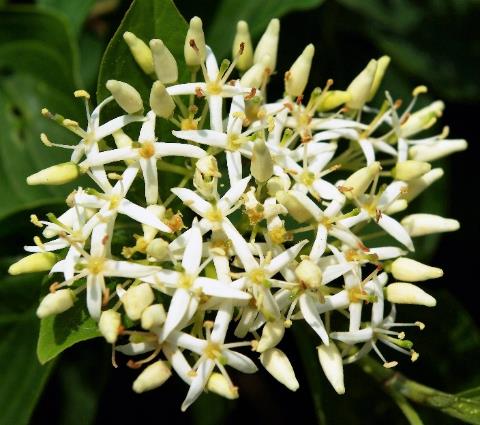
<box><xmin>0</xmin><ymin>267</ymin><xmax>54</xmax><ymax>425</ymax></box>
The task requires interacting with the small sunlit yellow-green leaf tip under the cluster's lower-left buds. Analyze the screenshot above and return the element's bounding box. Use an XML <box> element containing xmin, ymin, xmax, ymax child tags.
<box><xmin>37</xmin><ymin>302</ymin><xmax>100</xmax><ymax>364</ymax></box>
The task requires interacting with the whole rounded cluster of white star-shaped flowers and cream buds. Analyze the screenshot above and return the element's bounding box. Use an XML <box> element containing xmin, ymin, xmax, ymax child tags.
<box><xmin>9</xmin><ymin>17</ymin><xmax>467</xmax><ymax>410</ymax></box>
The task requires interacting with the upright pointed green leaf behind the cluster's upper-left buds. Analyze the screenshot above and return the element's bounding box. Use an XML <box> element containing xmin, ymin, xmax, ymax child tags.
<box><xmin>97</xmin><ymin>0</ymin><xmax>187</xmax><ymax>121</ymax></box>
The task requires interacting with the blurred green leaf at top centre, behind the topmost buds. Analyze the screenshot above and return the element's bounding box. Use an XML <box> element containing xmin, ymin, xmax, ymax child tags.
<box><xmin>207</xmin><ymin>0</ymin><xmax>325</xmax><ymax>58</ymax></box>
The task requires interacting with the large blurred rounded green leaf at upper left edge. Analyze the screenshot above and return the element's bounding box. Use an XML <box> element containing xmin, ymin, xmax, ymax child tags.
<box><xmin>0</xmin><ymin>8</ymin><xmax>82</xmax><ymax>219</ymax></box>
